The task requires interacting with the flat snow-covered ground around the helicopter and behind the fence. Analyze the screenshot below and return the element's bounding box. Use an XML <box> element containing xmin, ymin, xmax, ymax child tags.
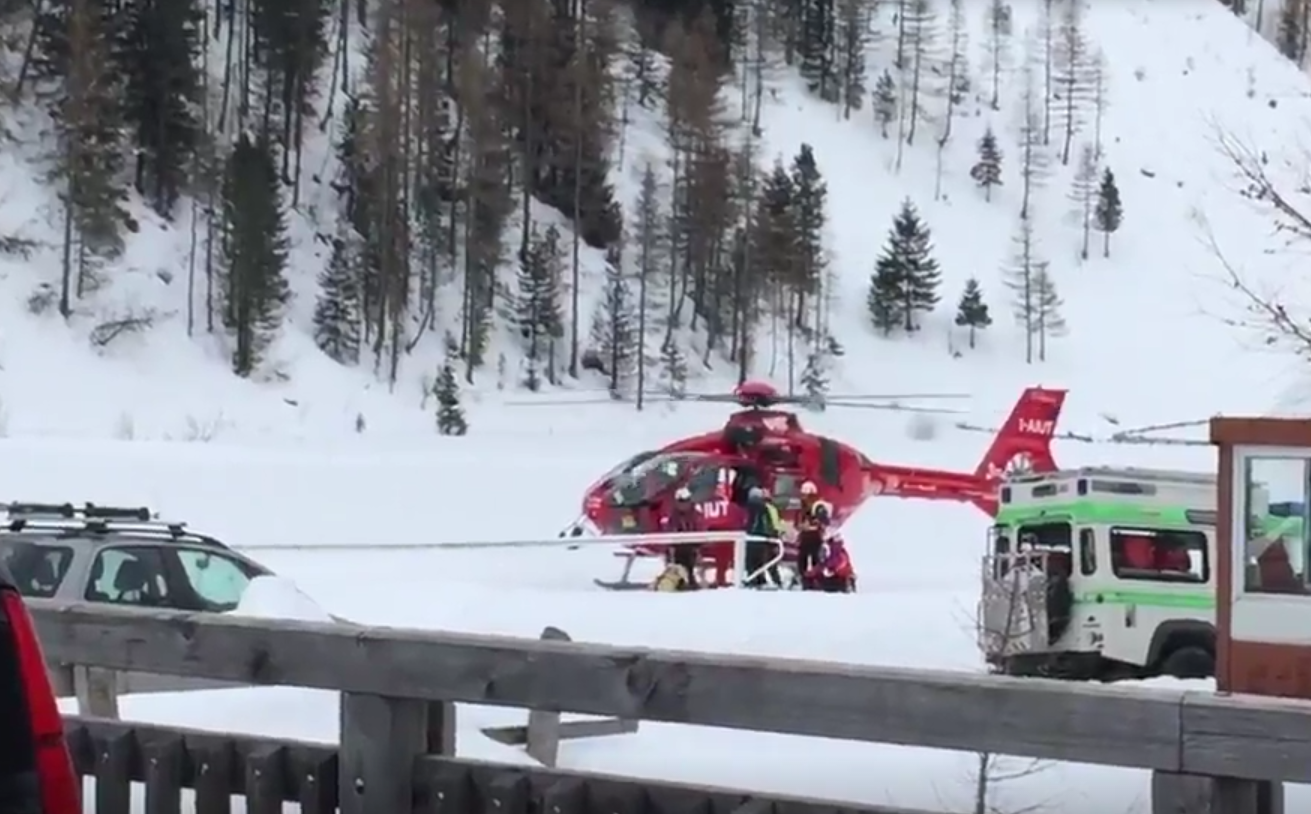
<box><xmin>23</xmin><ymin>417</ymin><xmax>1311</xmax><ymax>814</ymax></box>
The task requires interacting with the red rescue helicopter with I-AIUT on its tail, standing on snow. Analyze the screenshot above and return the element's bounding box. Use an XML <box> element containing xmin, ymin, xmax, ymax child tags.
<box><xmin>542</xmin><ymin>381</ymin><xmax>1066</xmax><ymax>590</ymax></box>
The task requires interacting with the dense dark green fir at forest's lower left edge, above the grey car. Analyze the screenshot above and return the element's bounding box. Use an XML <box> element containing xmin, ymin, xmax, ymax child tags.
<box><xmin>222</xmin><ymin>136</ymin><xmax>288</xmax><ymax>376</ymax></box>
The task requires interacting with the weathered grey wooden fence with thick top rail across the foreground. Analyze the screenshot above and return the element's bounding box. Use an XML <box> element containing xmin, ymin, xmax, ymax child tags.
<box><xmin>31</xmin><ymin>602</ymin><xmax>1311</xmax><ymax>814</ymax></box>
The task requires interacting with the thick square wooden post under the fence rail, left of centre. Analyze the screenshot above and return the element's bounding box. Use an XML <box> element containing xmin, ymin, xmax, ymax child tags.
<box><xmin>338</xmin><ymin>692</ymin><xmax>433</xmax><ymax>814</ymax></box>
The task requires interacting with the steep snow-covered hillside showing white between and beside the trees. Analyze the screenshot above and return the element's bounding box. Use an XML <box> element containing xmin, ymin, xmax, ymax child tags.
<box><xmin>0</xmin><ymin>0</ymin><xmax>1311</xmax><ymax>439</ymax></box>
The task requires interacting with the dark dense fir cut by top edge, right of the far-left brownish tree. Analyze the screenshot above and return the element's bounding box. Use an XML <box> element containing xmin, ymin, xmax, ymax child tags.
<box><xmin>115</xmin><ymin>0</ymin><xmax>207</xmax><ymax>218</ymax></box>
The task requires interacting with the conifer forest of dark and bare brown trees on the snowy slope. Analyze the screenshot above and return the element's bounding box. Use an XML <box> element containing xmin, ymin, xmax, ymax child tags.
<box><xmin>0</xmin><ymin>0</ymin><xmax>1148</xmax><ymax>411</ymax></box>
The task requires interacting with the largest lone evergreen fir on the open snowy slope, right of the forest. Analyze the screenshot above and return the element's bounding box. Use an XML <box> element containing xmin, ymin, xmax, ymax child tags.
<box><xmin>869</xmin><ymin>198</ymin><xmax>943</xmax><ymax>334</ymax></box>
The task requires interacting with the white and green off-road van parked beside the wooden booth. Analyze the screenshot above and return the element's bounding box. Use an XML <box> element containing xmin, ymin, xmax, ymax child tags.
<box><xmin>978</xmin><ymin>467</ymin><xmax>1232</xmax><ymax>680</ymax></box>
